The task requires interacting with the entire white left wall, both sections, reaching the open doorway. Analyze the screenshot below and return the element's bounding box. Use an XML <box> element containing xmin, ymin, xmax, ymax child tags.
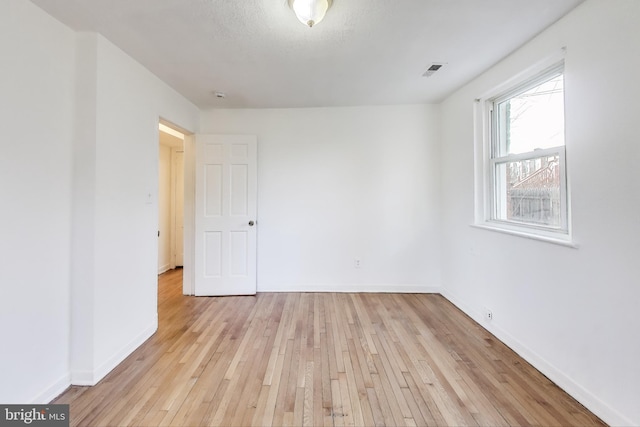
<box><xmin>0</xmin><ymin>0</ymin><xmax>199</xmax><ymax>403</ymax></box>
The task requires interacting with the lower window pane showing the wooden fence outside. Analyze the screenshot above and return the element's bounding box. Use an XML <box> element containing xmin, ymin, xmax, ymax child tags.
<box><xmin>495</xmin><ymin>154</ymin><xmax>562</xmax><ymax>228</ymax></box>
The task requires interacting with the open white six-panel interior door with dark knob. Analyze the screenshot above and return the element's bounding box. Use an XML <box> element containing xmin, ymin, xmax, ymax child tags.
<box><xmin>194</xmin><ymin>135</ymin><xmax>258</xmax><ymax>295</ymax></box>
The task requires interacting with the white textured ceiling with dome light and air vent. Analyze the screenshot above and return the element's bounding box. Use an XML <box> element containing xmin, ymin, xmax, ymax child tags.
<box><xmin>32</xmin><ymin>0</ymin><xmax>582</xmax><ymax>108</ymax></box>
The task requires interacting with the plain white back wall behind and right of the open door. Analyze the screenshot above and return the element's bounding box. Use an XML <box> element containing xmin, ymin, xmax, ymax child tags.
<box><xmin>201</xmin><ymin>106</ymin><xmax>440</xmax><ymax>291</ymax></box>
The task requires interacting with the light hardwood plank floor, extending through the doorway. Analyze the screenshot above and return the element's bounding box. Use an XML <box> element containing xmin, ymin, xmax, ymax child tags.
<box><xmin>53</xmin><ymin>270</ymin><xmax>603</xmax><ymax>426</ymax></box>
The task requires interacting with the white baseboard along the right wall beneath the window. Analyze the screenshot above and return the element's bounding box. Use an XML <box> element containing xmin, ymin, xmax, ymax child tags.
<box><xmin>441</xmin><ymin>289</ymin><xmax>637</xmax><ymax>426</ymax></box>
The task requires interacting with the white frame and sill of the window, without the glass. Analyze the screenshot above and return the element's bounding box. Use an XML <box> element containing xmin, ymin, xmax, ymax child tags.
<box><xmin>473</xmin><ymin>54</ymin><xmax>577</xmax><ymax>247</ymax></box>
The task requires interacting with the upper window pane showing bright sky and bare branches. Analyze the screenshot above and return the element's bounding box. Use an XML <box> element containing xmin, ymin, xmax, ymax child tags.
<box><xmin>496</xmin><ymin>74</ymin><xmax>564</xmax><ymax>156</ymax></box>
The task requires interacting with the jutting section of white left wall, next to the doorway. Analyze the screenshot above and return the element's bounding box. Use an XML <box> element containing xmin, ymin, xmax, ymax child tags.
<box><xmin>71</xmin><ymin>34</ymin><xmax>198</xmax><ymax>384</ymax></box>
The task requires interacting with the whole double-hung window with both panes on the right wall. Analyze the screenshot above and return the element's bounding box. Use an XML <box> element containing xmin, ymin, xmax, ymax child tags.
<box><xmin>484</xmin><ymin>63</ymin><xmax>569</xmax><ymax>241</ymax></box>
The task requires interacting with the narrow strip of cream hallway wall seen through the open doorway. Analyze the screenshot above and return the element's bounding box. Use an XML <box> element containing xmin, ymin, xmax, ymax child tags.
<box><xmin>158</xmin><ymin>142</ymin><xmax>171</xmax><ymax>274</ymax></box>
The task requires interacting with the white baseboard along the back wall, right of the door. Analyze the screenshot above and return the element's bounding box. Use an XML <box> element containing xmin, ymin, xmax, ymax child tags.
<box><xmin>258</xmin><ymin>283</ymin><xmax>441</xmax><ymax>294</ymax></box>
